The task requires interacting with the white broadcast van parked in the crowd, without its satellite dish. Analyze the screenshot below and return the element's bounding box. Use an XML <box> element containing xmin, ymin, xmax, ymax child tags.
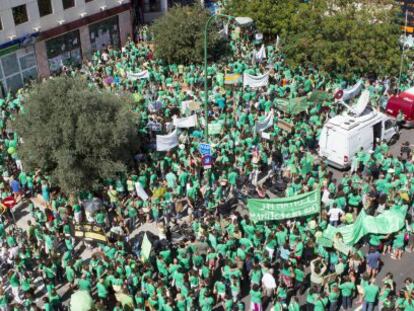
<box><xmin>319</xmin><ymin>107</ymin><xmax>399</xmax><ymax>169</ymax></box>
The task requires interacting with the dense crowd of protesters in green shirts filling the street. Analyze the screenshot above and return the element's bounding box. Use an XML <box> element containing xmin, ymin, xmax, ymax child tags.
<box><xmin>0</xmin><ymin>22</ymin><xmax>414</xmax><ymax>311</ymax></box>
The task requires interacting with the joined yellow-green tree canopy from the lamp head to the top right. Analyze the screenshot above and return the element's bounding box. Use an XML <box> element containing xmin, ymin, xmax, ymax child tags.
<box><xmin>227</xmin><ymin>0</ymin><xmax>401</xmax><ymax>75</ymax></box>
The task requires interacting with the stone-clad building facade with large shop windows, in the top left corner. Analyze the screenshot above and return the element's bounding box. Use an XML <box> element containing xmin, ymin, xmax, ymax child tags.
<box><xmin>0</xmin><ymin>0</ymin><xmax>133</xmax><ymax>96</ymax></box>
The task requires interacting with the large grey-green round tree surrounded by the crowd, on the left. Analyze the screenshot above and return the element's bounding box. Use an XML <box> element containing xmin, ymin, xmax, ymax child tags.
<box><xmin>13</xmin><ymin>77</ymin><xmax>138</xmax><ymax>193</ymax></box>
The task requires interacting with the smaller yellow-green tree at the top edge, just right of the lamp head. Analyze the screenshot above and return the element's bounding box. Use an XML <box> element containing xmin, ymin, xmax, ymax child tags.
<box><xmin>225</xmin><ymin>0</ymin><xmax>300</xmax><ymax>37</ymax></box>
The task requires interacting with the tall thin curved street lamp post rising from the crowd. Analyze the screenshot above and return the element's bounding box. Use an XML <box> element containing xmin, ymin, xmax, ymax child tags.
<box><xmin>204</xmin><ymin>14</ymin><xmax>253</xmax><ymax>144</ymax></box>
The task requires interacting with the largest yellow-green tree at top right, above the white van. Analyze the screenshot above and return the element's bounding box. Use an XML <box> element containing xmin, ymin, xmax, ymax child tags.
<box><xmin>283</xmin><ymin>0</ymin><xmax>400</xmax><ymax>75</ymax></box>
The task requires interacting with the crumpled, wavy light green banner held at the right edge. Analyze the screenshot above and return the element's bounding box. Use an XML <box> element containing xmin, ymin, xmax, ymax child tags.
<box><xmin>323</xmin><ymin>207</ymin><xmax>407</xmax><ymax>246</ymax></box>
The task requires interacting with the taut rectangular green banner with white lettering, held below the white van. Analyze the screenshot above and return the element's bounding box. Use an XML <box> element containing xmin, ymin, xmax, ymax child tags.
<box><xmin>247</xmin><ymin>189</ymin><xmax>321</xmax><ymax>222</ymax></box>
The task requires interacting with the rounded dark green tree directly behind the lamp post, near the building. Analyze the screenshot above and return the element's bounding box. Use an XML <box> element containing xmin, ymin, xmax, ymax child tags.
<box><xmin>151</xmin><ymin>5</ymin><xmax>225</xmax><ymax>64</ymax></box>
